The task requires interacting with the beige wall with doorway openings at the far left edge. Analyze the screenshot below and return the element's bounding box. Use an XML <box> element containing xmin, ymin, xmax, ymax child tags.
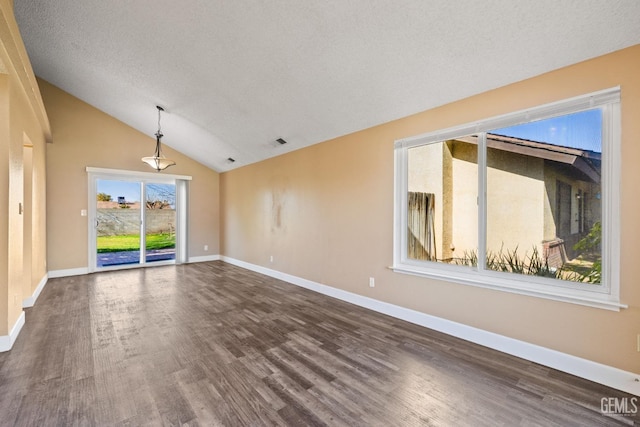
<box><xmin>0</xmin><ymin>0</ymin><xmax>50</xmax><ymax>336</ymax></box>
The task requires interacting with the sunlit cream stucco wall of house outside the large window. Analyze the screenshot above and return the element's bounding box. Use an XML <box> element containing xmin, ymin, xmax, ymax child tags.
<box><xmin>408</xmin><ymin>141</ymin><xmax>553</xmax><ymax>259</ymax></box>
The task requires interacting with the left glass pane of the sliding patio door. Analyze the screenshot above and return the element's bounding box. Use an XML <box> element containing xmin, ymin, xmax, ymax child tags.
<box><xmin>96</xmin><ymin>179</ymin><xmax>141</xmax><ymax>267</ymax></box>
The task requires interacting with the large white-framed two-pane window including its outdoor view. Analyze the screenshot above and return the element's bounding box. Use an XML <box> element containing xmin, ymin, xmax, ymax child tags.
<box><xmin>394</xmin><ymin>89</ymin><xmax>622</xmax><ymax>309</ymax></box>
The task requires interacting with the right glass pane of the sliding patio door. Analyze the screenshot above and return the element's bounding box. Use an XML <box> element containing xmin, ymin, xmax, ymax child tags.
<box><xmin>144</xmin><ymin>183</ymin><xmax>176</xmax><ymax>262</ymax></box>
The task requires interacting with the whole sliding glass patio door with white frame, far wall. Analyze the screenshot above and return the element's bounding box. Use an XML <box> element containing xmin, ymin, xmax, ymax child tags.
<box><xmin>87</xmin><ymin>168</ymin><xmax>190</xmax><ymax>271</ymax></box>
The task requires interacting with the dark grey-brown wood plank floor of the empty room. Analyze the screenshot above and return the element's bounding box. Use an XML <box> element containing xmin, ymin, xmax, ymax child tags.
<box><xmin>0</xmin><ymin>262</ymin><xmax>640</xmax><ymax>426</ymax></box>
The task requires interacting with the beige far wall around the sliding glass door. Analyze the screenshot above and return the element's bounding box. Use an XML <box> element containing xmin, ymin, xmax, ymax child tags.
<box><xmin>39</xmin><ymin>80</ymin><xmax>219</xmax><ymax>271</ymax></box>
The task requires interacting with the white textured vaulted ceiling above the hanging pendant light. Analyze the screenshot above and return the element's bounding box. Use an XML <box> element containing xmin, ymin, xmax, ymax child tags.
<box><xmin>15</xmin><ymin>0</ymin><xmax>640</xmax><ymax>172</ymax></box>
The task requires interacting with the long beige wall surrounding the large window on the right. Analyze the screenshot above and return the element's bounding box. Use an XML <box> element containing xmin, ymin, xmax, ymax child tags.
<box><xmin>220</xmin><ymin>46</ymin><xmax>640</xmax><ymax>372</ymax></box>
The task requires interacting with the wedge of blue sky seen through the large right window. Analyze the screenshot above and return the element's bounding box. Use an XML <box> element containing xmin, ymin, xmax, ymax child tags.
<box><xmin>490</xmin><ymin>109</ymin><xmax>602</xmax><ymax>153</ymax></box>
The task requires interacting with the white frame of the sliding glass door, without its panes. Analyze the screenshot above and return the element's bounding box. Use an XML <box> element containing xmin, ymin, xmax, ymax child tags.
<box><xmin>86</xmin><ymin>166</ymin><xmax>192</xmax><ymax>273</ymax></box>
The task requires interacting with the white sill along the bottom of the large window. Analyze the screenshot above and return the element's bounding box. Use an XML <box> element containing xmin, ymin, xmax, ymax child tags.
<box><xmin>389</xmin><ymin>265</ymin><xmax>628</xmax><ymax>311</ymax></box>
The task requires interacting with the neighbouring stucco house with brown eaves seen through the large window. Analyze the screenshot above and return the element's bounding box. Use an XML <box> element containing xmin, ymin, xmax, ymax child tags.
<box><xmin>408</xmin><ymin>134</ymin><xmax>601</xmax><ymax>267</ymax></box>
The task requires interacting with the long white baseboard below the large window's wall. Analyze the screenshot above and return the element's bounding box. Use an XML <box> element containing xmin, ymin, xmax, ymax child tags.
<box><xmin>220</xmin><ymin>256</ymin><xmax>640</xmax><ymax>396</ymax></box>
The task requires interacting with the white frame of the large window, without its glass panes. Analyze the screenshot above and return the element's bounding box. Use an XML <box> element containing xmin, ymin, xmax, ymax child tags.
<box><xmin>391</xmin><ymin>87</ymin><xmax>627</xmax><ymax>311</ymax></box>
